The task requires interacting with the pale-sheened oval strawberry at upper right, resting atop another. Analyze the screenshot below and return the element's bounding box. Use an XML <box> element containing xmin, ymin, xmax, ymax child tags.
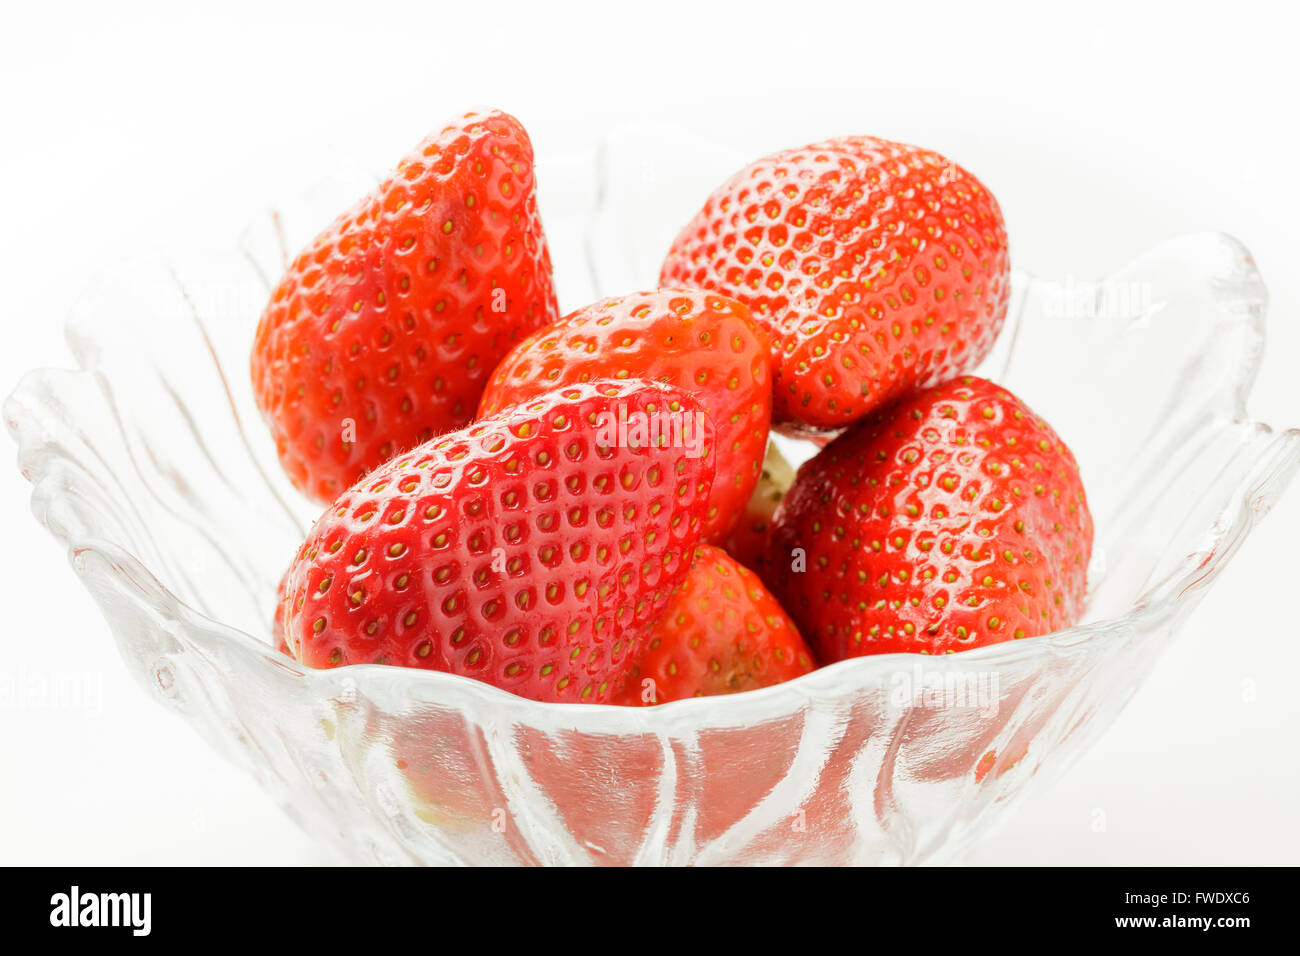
<box><xmin>660</xmin><ymin>137</ymin><xmax>1009</xmax><ymax>433</ymax></box>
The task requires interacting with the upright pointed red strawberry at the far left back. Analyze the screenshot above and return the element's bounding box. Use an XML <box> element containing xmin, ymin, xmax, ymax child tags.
<box><xmin>252</xmin><ymin>111</ymin><xmax>558</xmax><ymax>502</ymax></box>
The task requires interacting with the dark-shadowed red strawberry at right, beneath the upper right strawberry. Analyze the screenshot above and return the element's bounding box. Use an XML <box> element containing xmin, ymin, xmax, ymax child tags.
<box><xmin>767</xmin><ymin>377</ymin><xmax>1092</xmax><ymax>662</ymax></box>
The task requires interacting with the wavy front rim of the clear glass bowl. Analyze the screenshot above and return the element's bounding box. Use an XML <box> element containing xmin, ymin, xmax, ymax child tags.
<box><xmin>4</xmin><ymin>233</ymin><xmax>1300</xmax><ymax>734</ymax></box>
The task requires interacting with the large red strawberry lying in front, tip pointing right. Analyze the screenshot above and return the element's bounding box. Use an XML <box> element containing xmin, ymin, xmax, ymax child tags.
<box><xmin>285</xmin><ymin>381</ymin><xmax>714</xmax><ymax>702</ymax></box>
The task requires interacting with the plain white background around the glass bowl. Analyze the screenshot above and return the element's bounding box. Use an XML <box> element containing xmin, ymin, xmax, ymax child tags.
<box><xmin>0</xmin><ymin>0</ymin><xmax>1300</xmax><ymax>864</ymax></box>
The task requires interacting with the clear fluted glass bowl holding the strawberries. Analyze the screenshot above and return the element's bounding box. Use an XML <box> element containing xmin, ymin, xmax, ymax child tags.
<box><xmin>4</xmin><ymin>127</ymin><xmax>1300</xmax><ymax>864</ymax></box>
